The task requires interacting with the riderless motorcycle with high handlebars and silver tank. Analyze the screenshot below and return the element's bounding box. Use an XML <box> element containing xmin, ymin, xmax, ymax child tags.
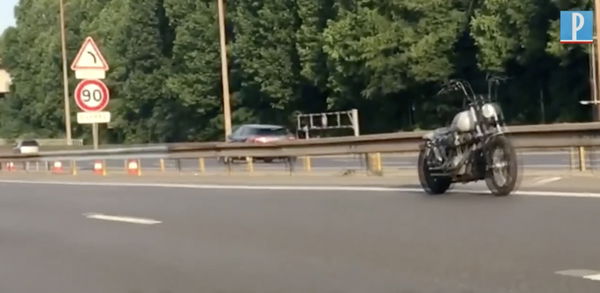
<box><xmin>418</xmin><ymin>77</ymin><xmax>518</xmax><ymax>196</ymax></box>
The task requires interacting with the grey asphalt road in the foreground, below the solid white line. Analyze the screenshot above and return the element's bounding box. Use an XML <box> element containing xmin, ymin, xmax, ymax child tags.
<box><xmin>0</xmin><ymin>183</ymin><xmax>600</xmax><ymax>293</ymax></box>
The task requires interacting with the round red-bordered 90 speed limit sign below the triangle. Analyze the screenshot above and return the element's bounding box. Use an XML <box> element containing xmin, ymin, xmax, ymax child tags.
<box><xmin>75</xmin><ymin>80</ymin><xmax>110</xmax><ymax>112</ymax></box>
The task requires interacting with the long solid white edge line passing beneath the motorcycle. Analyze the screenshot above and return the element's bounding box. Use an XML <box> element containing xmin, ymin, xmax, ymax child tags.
<box><xmin>0</xmin><ymin>180</ymin><xmax>600</xmax><ymax>198</ymax></box>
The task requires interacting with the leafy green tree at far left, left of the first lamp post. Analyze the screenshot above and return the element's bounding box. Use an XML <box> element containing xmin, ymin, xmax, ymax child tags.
<box><xmin>1</xmin><ymin>0</ymin><xmax>64</xmax><ymax>136</ymax></box>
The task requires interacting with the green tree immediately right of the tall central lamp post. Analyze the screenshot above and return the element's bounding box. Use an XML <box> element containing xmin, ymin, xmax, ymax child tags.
<box><xmin>232</xmin><ymin>0</ymin><xmax>300</xmax><ymax>122</ymax></box>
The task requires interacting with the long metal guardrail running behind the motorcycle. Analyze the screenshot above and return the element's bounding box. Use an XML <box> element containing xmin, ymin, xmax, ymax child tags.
<box><xmin>0</xmin><ymin>122</ymin><xmax>600</xmax><ymax>171</ymax></box>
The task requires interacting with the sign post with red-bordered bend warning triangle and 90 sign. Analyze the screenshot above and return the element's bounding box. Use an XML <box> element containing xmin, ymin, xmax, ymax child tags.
<box><xmin>71</xmin><ymin>37</ymin><xmax>111</xmax><ymax>150</ymax></box>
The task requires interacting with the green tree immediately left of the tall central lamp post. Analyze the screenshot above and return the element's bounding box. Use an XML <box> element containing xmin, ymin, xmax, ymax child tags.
<box><xmin>165</xmin><ymin>0</ymin><xmax>223</xmax><ymax>140</ymax></box>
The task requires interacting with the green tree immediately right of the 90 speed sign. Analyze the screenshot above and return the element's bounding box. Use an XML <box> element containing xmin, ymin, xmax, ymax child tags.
<box><xmin>86</xmin><ymin>0</ymin><xmax>176</xmax><ymax>143</ymax></box>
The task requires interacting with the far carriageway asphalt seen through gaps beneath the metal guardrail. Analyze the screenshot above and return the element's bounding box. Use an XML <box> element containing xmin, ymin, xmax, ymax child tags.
<box><xmin>38</xmin><ymin>152</ymin><xmax>600</xmax><ymax>172</ymax></box>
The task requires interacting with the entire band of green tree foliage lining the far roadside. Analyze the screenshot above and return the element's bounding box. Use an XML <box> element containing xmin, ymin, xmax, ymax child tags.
<box><xmin>0</xmin><ymin>0</ymin><xmax>592</xmax><ymax>143</ymax></box>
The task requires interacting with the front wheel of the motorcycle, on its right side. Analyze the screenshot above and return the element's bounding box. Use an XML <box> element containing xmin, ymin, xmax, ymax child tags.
<box><xmin>485</xmin><ymin>136</ymin><xmax>518</xmax><ymax>196</ymax></box>
